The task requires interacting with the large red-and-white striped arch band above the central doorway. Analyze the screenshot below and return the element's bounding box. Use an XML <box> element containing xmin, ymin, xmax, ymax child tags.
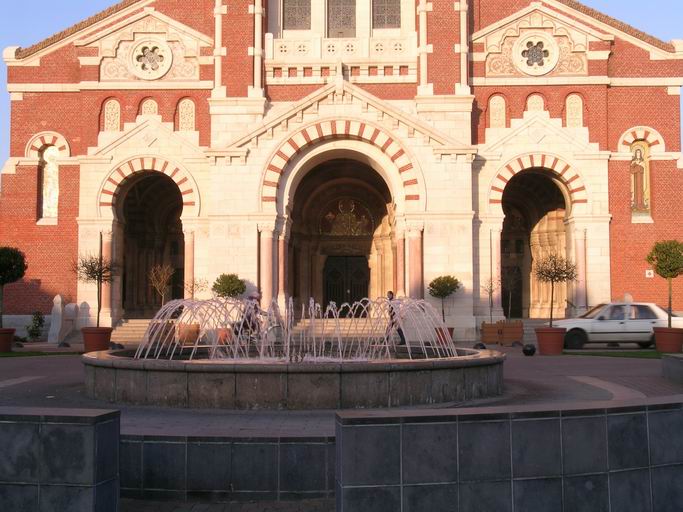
<box><xmin>261</xmin><ymin>120</ymin><xmax>420</xmax><ymax>205</ymax></box>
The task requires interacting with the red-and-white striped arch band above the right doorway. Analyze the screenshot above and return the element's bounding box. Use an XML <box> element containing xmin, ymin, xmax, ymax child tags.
<box><xmin>489</xmin><ymin>153</ymin><xmax>588</xmax><ymax>205</ymax></box>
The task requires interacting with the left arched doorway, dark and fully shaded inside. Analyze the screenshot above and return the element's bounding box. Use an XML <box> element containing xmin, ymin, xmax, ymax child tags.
<box><xmin>117</xmin><ymin>171</ymin><xmax>184</xmax><ymax>318</ymax></box>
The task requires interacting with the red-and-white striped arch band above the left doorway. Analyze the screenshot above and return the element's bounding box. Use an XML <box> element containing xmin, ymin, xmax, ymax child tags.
<box><xmin>98</xmin><ymin>157</ymin><xmax>199</xmax><ymax>217</ymax></box>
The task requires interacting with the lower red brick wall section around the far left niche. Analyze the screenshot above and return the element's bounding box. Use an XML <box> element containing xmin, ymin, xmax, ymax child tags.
<box><xmin>0</xmin><ymin>166</ymin><xmax>79</xmax><ymax>315</ymax></box>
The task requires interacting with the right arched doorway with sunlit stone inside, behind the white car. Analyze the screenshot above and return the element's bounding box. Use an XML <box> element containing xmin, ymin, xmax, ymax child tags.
<box><xmin>501</xmin><ymin>169</ymin><xmax>568</xmax><ymax>318</ymax></box>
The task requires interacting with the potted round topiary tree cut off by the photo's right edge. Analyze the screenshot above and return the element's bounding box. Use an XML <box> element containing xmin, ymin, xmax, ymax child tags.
<box><xmin>646</xmin><ymin>240</ymin><xmax>683</xmax><ymax>352</ymax></box>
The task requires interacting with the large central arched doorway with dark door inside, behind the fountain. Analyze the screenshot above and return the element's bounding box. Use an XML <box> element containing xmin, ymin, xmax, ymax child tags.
<box><xmin>288</xmin><ymin>158</ymin><xmax>396</xmax><ymax>304</ymax></box>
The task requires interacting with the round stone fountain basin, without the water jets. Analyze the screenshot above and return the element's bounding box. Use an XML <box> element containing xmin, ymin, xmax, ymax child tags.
<box><xmin>82</xmin><ymin>348</ymin><xmax>505</xmax><ymax>410</ymax></box>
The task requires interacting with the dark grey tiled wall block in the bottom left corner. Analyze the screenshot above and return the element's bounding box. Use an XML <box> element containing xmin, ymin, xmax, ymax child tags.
<box><xmin>0</xmin><ymin>407</ymin><xmax>119</xmax><ymax>512</ymax></box>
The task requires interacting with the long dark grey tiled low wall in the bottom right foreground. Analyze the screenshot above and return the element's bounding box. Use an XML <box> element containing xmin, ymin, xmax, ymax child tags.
<box><xmin>336</xmin><ymin>397</ymin><xmax>683</xmax><ymax>512</ymax></box>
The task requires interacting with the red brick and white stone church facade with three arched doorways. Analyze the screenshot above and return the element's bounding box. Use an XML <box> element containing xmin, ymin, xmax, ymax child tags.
<box><xmin>0</xmin><ymin>0</ymin><xmax>683</xmax><ymax>339</ymax></box>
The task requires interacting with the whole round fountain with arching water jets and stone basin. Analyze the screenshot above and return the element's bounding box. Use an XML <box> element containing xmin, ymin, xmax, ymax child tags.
<box><xmin>83</xmin><ymin>298</ymin><xmax>504</xmax><ymax>409</ymax></box>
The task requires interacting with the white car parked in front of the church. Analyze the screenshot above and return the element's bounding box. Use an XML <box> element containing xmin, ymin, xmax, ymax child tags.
<box><xmin>553</xmin><ymin>302</ymin><xmax>683</xmax><ymax>349</ymax></box>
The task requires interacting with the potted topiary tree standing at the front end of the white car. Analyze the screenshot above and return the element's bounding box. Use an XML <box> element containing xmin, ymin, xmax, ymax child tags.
<box><xmin>534</xmin><ymin>254</ymin><xmax>577</xmax><ymax>356</ymax></box>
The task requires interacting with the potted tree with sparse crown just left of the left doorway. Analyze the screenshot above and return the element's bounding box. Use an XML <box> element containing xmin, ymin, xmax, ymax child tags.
<box><xmin>73</xmin><ymin>247</ymin><xmax>114</xmax><ymax>352</ymax></box>
